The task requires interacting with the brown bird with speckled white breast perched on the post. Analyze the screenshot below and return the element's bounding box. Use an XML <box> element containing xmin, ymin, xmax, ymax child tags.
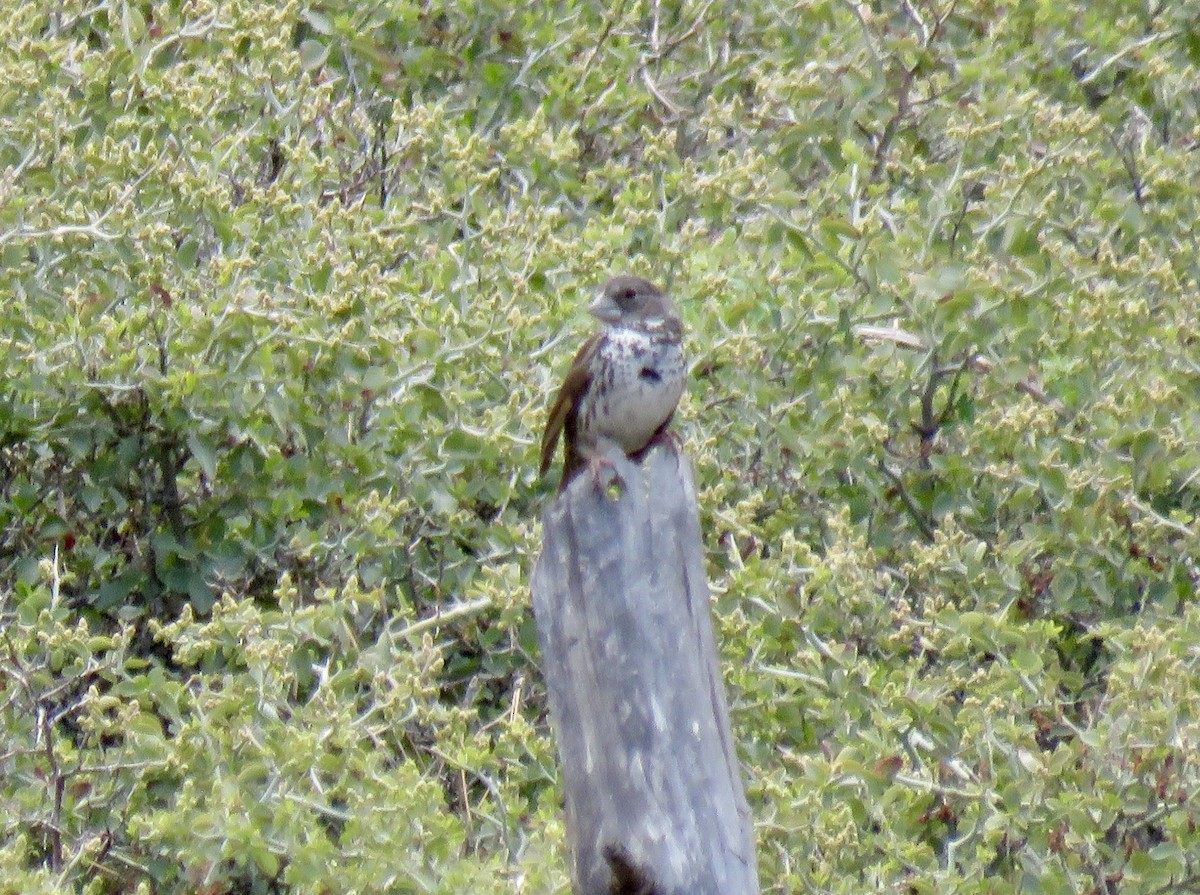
<box><xmin>541</xmin><ymin>276</ymin><xmax>686</xmax><ymax>491</ymax></box>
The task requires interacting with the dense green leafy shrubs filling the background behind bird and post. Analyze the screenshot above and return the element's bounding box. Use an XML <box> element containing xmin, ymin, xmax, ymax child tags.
<box><xmin>0</xmin><ymin>0</ymin><xmax>1200</xmax><ymax>895</ymax></box>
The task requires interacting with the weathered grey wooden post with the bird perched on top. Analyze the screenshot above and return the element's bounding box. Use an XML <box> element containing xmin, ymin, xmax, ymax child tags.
<box><xmin>533</xmin><ymin>449</ymin><xmax>758</xmax><ymax>895</ymax></box>
